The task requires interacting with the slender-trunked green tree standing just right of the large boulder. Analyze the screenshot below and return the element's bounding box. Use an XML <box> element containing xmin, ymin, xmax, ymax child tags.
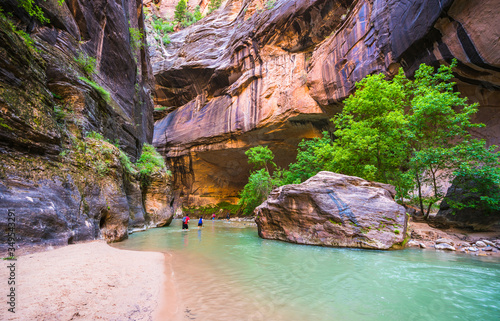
<box><xmin>406</xmin><ymin>61</ymin><xmax>484</xmax><ymax>218</ymax></box>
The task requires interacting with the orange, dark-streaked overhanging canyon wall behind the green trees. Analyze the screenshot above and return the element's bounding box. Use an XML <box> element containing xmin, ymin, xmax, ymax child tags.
<box><xmin>151</xmin><ymin>0</ymin><xmax>500</xmax><ymax>205</ymax></box>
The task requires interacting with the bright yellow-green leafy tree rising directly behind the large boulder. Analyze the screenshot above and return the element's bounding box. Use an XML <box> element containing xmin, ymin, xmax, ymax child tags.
<box><xmin>332</xmin><ymin>70</ymin><xmax>409</xmax><ymax>183</ymax></box>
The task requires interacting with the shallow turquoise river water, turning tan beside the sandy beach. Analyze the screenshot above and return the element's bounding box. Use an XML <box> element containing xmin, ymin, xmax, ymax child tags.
<box><xmin>115</xmin><ymin>220</ymin><xmax>500</xmax><ymax>321</ymax></box>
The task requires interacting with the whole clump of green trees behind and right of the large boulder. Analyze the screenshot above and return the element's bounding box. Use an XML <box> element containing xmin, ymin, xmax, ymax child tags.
<box><xmin>239</xmin><ymin>61</ymin><xmax>500</xmax><ymax>217</ymax></box>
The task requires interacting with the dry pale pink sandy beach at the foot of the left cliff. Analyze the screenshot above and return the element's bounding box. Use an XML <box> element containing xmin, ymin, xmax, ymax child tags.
<box><xmin>0</xmin><ymin>241</ymin><xmax>165</xmax><ymax>321</ymax></box>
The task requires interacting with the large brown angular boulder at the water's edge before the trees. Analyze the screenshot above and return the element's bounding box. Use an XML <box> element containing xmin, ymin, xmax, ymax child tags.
<box><xmin>256</xmin><ymin>172</ymin><xmax>408</xmax><ymax>250</ymax></box>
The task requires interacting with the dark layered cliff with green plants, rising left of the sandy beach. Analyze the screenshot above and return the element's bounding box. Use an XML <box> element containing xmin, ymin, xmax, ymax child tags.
<box><xmin>0</xmin><ymin>0</ymin><xmax>172</xmax><ymax>250</ymax></box>
